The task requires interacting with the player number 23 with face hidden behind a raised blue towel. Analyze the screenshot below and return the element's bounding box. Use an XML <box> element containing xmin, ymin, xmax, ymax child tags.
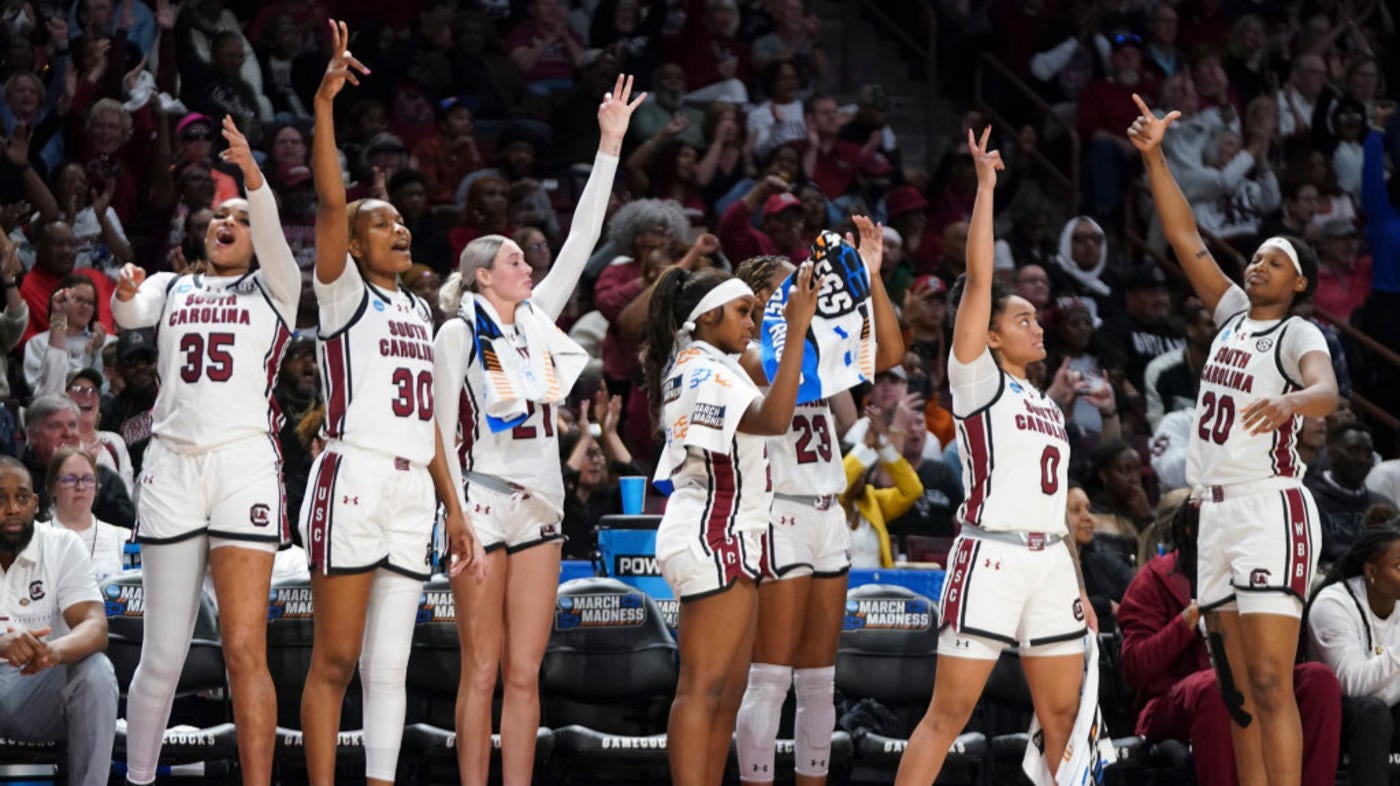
<box><xmin>736</xmin><ymin>216</ymin><xmax>904</xmax><ymax>786</ymax></box>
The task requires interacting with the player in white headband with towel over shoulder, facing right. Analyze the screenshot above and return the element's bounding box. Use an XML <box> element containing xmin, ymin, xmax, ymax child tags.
<box><xmin>643</xmin><ymin>262</ymin><xmax>820</xmax><ymax>786</ymax></box>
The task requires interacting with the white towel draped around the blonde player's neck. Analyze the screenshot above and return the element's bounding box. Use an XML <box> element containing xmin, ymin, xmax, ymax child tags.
<box><xmin>458</xmin><ymin>294</ymin><xmax>588</xmax><ymax>433</ymax></box>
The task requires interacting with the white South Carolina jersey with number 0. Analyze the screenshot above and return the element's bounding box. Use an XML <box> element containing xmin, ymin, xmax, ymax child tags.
<box><xmin>948</xmin><ymin>350</ymin><xmax>1070</xmax><ymax>534</ymax></box>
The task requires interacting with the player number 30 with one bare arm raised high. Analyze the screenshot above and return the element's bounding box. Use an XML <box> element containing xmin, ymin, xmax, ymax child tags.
<box><xmin>301</xmin><ymin>22</ymin><xmax>484</xmax><ymax>786</ymax></box>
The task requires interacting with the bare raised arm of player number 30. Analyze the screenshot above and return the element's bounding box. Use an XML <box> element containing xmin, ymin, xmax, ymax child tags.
<box><xmin>311</xmin><ymin>21</ymin><xmax>370</xmax><ymax>284</ymax></box>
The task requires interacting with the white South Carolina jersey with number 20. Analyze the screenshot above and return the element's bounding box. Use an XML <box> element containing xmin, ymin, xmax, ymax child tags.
<box><xmin>1186</xmin><ymin>287</ymin><xmax>1327</xmax><ymax>486</ymax></box>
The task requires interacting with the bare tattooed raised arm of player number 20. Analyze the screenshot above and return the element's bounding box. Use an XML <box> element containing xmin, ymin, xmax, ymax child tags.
<box><xmin>1128</xmin><ymin>94</ymin><xmax>1231</xmax><ymax>314</ymax></box>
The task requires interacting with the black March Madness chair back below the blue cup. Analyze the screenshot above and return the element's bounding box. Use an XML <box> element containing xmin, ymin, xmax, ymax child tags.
<box><xmin>540</xmin><ymin>579</ymin><xmax>679</xmax><ymax>736</ymax></box>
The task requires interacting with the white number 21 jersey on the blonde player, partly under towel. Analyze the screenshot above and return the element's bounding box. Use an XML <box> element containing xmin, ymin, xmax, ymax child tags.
<box><xmin>435</xmin><ymin>312</ymin><xmax>564</xmax><ymax>510</ymax></box>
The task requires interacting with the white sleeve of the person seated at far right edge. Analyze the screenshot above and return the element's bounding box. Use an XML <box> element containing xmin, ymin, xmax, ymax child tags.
<box><xmin>1308</xmin><ymin>584</ymin><xmax>1400</xmax><ymax>705</ymax></box>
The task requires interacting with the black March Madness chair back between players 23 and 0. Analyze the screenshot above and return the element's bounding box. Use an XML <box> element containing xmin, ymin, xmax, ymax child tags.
<box><xmin>836</xmin><ymin>584</ymin><xmax>938</xmax><ymax>712</ymax></box>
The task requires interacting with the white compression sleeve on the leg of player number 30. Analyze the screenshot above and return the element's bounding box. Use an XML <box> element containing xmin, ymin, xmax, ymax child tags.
<box><xmin>360</xmin><ymin>569</ymin><xmax>423</xmax><ymax>780</ymax></box>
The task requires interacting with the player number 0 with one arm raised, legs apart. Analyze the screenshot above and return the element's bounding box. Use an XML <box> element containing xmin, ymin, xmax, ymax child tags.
<box><xmin>895</xmin><ymin>127</ymin><xmax>1089</xmax><ymax>786</ymax></box>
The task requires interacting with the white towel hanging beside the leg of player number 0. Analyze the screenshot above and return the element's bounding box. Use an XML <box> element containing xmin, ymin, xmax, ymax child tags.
<box><xmin>1021</xmin><ymin>632</ymin><xmax>1117</xmax><ymax>786</ymax></box>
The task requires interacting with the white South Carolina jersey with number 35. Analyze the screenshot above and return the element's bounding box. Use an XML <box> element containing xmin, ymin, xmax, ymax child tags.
<box><xmin>151</xmin><ymin>270</ymin><xmax>291</xmax><ymax>451</ymax></box>
